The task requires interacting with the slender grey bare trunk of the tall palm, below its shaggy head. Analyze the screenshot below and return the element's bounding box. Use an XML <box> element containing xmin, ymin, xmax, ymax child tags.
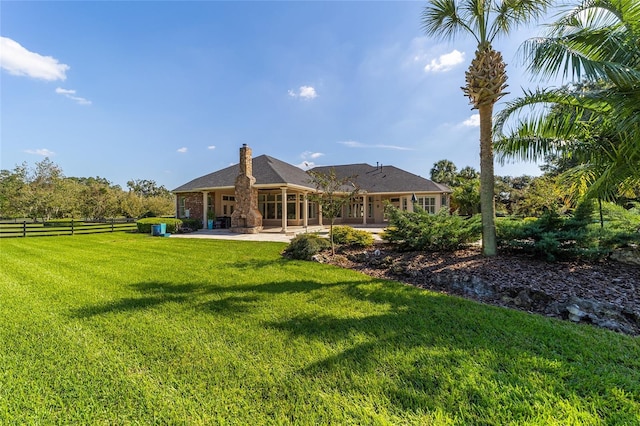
<box><xmin>478</xmin><ymin>103</ymin><xmax>497</xmax><ymax>256</ymax></box>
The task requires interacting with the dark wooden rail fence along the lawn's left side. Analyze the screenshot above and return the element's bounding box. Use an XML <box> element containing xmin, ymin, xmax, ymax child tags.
<box><xmin>0</xmin><ymin>219</ymin><xmax>137</xmax><ymax>238</ymax></box>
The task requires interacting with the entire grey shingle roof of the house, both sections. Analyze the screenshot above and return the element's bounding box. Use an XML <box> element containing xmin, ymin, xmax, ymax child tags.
<box><xmin>172</xmin><ymin>155</ymin><xmax>451</xmax><ymax>193</ymax></box>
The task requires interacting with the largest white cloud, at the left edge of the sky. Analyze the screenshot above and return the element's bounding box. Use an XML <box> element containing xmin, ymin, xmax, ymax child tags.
<box><xmin>0</xmin><ymin>37</ymin><xmax>70</xmax><ymax>81</ymax></box>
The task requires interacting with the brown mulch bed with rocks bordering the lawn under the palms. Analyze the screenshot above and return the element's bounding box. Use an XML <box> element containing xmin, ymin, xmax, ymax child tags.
<box><xmin>322</xmin><ymin>244</ymin><xmax>640</xmax><ymax>336</ymax></box>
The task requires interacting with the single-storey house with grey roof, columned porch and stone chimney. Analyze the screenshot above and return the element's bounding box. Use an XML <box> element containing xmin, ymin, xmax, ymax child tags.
<box><xmin>172</xmin><ymin>144</ymin><xmax>451</xmax><ymax>233</ymax></box>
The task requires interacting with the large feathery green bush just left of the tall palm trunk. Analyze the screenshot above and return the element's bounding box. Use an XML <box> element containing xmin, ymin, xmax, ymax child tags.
<box><xmin>383</xmin><ymin>206</ymin><xmax>482</xmax><ymax>251</ymax></box>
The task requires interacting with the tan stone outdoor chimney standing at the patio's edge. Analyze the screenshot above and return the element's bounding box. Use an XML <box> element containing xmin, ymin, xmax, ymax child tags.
<box><xmin>231</xmin><ymin>144</ymin><xmax>262</xmax><ymax>234</ymax></box>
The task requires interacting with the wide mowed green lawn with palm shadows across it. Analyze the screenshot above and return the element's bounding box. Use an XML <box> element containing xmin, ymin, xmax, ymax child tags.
<box><xmin>0</xmin><ymin>233</ymin><xmax>640</xmax><ymax>425</ymax></box>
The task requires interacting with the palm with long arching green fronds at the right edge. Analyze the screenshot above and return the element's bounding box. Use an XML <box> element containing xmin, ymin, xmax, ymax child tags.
<box><xmin>495</xmin><ymin>0</ymin><xmax>640</xmax><ymax>203</ymax></box>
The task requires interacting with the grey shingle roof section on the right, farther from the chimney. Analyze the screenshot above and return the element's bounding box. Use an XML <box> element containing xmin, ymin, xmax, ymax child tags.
<box><xmin>311</xmin><ymin>163</ymin><xmax>451</xmax><ymax>193</ymax></box>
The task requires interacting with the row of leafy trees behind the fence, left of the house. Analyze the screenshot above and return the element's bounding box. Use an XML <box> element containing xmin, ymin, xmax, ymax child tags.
<box><xmin>0</xmin><ymin>158</ymin><xmax>174</xmax><ymax>221</ymax></box>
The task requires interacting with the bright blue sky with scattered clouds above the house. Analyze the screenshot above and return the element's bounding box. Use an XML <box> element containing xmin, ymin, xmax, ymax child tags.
<box><xmin>0</xmin><ymin>1</ymin><xmax>552</xmax><ymax>189</ymax></box>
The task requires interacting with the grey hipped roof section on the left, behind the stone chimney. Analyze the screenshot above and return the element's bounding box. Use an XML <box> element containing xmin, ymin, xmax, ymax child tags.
<box><xmin>172</xmin><ymin>155</ymin><xmax>313</xmax><ymax>192</ymax></box>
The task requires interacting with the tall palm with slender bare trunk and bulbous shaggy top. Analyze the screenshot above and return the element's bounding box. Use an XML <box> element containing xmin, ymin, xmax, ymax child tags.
<box><xmin>422</xmin><ymin>0</ymin><xmax>551</xmax><ymax>256</ymax></box>
